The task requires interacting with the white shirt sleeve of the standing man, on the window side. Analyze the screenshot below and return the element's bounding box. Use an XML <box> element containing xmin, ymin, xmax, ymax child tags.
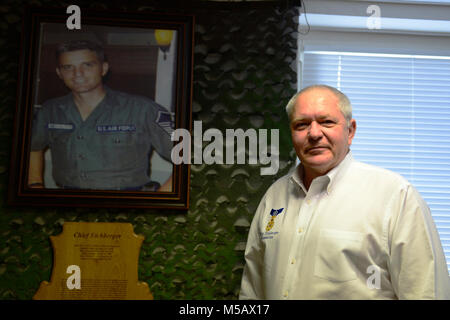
<box><xmin>389</xmin><ymin>185</ymin><xmax>450</xmax><ymax>300</ymax></box>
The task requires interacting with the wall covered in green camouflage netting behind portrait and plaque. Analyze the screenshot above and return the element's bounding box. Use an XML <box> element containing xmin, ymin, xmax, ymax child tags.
<box><xmin>0</xmin><ymin>1</ymin><xmax>297</xmax><ymax>299</ymax></box>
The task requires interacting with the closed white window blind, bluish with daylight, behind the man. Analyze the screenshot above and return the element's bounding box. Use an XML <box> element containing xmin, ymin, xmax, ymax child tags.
<box><xmin>302</xmin><ymin>51</ymin><xmax>450</xmax><ymax>272</ymax></box>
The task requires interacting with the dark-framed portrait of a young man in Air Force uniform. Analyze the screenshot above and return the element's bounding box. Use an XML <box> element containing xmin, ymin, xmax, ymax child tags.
<box><xmin>8</xmin><ymin>8</ymin><xmax>194</xmax><ymax>209</ymax></box>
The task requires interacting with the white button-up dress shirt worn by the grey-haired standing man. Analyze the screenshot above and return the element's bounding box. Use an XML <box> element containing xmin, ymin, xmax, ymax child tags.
<box><xmin>240</xmin><ymin>152</ymin><xmax>450</xmax><ymax>299</ymax></box>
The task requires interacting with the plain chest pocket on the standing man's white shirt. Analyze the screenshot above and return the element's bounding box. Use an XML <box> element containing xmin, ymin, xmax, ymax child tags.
<box><xmin>314</xmin><ymin>229</ymin><xmax>363</xmax><ymax>282</ymax></box>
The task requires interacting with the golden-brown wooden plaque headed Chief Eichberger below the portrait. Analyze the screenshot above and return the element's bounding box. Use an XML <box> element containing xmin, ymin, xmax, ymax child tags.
<box><xmin>33</xmin><ymin>222</ymin><xmax>153</xmax><ymax>300</ymax></box>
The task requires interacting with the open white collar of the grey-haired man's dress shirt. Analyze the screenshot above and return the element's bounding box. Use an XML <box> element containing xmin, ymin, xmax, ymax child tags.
<box><xmin>290</xmin><ymin>151</ymin><xmax>353</xmax><ymax>194</ymax></box>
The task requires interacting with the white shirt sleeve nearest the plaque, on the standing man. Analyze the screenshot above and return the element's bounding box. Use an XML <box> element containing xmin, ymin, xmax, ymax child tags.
<box><xmin>239</xmin><ymin>192</ymin><xmax>266</xmax><ymax>300</ymax></box>
